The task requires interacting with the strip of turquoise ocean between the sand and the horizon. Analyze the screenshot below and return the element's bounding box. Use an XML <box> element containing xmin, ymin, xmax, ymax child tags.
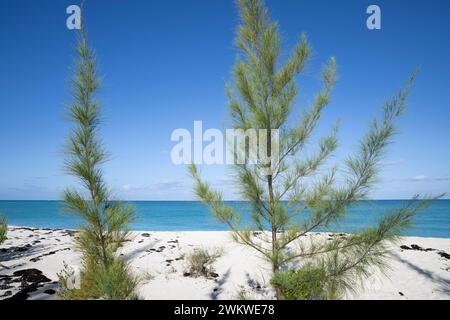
<box><xmin>0</xmin><ymin>200</ymin><xmax>450</xmax><ymax>238</ymax></box>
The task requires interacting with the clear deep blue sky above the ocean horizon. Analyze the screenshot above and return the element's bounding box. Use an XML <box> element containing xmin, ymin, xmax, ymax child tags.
<box><xmin>0</xmin><ymin>0</ymin><xmax>450</xmax><ymax>200</ymax></box>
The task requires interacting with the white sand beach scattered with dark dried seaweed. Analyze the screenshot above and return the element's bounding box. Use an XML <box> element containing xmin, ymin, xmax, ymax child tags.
<box><xmin>0</xmin><ymin>226</ymin><xmax>450</xmax><ymax>299</ymax></box>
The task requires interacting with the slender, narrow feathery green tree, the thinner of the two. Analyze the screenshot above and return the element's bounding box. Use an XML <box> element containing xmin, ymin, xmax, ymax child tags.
<box><xmin>60</xmin><ymin>18</ymin><xmax>136</xmax><ymax>299</ymax></box>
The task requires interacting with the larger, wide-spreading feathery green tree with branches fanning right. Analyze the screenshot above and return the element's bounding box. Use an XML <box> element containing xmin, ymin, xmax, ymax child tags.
<box><xmin>190</xmin><ymin>0</ymin><xmax>425</xmax><ymax>299</ymax></box>
